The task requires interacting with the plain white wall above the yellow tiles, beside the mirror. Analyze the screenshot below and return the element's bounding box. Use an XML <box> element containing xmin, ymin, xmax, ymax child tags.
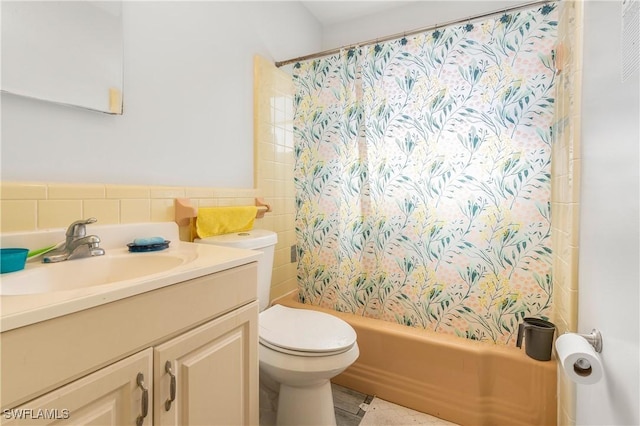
<box><xmin>1</xmin><ymin>1</ymin><xmax>321</xmax><ymax>188</ymax></box>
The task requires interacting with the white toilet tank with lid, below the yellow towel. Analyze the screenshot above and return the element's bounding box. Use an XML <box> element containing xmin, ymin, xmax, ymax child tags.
<box><xmin>193</xmin><ymin>229</ymin><xmax>278</xmax><ymax>312</ymax></box>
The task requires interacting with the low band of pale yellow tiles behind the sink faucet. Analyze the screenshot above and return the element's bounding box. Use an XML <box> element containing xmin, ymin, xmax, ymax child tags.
<box><xmin>0</xmin><ymin>182</ymin><xmax>257</xmax><ymax>233</ymax></box>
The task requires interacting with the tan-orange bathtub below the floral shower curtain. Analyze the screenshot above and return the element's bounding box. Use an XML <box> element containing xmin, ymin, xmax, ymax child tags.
<box><xmin>274</xmin><ymin>292</ymin><xmax>556</xmax><ymax>426</ymax></box>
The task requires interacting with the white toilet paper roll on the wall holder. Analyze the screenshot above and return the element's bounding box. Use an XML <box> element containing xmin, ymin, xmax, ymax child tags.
<box><xmin>555</xmin><ymin>333</ymin><xmax>603</xmax><ymax>385</ymax></box>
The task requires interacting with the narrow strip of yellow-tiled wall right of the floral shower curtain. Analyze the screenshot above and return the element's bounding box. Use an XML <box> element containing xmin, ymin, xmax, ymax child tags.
<box><xmin>551</xmin><ymin>0</ymin><xmax>583</xmax><ymax>425</ymax></box>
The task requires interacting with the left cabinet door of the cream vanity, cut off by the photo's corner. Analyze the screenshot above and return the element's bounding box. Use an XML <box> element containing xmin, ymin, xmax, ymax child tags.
<box><xmin>2</xmin><ymin>348</ymin><xmax>153</xmax><ymax>426</ymax></box>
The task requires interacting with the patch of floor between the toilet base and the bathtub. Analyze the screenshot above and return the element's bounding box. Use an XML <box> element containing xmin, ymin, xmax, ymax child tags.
<box><xmin>331</xmin><ymin>384</ymin><xmax>456</xmax><ymax>426</ymax></box>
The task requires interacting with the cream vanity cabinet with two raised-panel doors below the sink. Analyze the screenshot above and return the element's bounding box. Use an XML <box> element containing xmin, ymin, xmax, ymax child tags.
<box><xmin>0</xmin><ymin>263</ymin><xmax>258</xmax><ymax>426</ymax></box>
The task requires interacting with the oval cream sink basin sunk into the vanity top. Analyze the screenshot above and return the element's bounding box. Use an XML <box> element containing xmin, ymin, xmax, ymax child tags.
<box><xmin>0</xmin><ymin>250</ymin><xmax>195</xmax><ymax>296</ymax></box>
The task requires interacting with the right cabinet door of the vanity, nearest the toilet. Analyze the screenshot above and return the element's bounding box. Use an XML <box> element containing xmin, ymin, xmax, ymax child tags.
<box><xmin>153</xmin><ymin>302</ymin><xmax>258</xmax><ymax>426</ymax></box>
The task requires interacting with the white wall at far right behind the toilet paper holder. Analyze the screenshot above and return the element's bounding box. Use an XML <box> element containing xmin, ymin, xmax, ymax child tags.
<box><xmin>576</xmin><ymin>1</ymin><xmax>640</xmax><ymax>425</ymax></box>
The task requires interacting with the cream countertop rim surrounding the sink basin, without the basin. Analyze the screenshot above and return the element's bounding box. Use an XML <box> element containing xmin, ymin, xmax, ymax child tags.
<box><xmin>0</xmin><ymin>224</ymin><xmax>262</xmax><ymax>332</ymax></box>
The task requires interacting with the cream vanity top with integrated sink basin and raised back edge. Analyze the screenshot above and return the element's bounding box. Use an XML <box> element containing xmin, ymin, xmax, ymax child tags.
<box><xmin>0</xmin><ymin>222</ymin><xmax>262</xmax><ymax>332</ymax></box>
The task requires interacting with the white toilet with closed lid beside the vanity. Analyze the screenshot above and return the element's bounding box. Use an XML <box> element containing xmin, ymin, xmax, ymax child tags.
<box><xmin>194</xmin><ymin>229</ymin><xmax>360</xmax><ymax>426</ymax></box>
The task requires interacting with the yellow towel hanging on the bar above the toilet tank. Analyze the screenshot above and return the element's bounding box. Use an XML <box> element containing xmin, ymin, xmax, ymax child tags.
<box><xmin>196</xmin><ymin>206</ymin><xmax>258</xmax><ymax>238</ymax></box>
